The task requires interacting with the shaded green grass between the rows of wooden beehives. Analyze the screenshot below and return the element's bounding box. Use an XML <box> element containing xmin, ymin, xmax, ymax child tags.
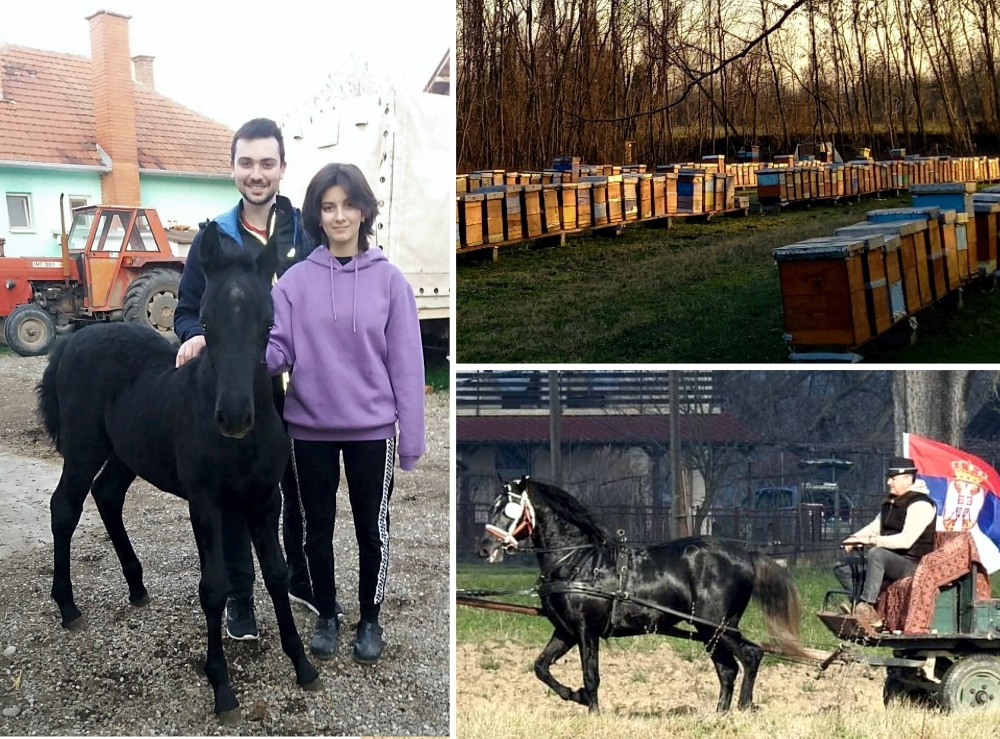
<box><xmin>456</xmin><ymin>195</ymin><xmax>1000</xmax><ymax>363</ymax></box>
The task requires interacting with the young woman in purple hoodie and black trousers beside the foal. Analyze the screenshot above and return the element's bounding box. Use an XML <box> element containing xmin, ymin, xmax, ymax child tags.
<box><xmin>267</xmin><ymin>164</ymin><xmax>424</xmax><ymax>664</ymax></box>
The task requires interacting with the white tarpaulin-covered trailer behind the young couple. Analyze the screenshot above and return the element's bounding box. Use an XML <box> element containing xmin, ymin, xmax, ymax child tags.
<box><xmin>281</xmin><ymin>93</ymin><xmax>455</xmax><ymax>337</ymax></box>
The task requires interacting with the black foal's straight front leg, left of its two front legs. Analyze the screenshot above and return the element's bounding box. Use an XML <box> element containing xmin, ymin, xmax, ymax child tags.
<box><xmin>188</xmin><ymin>500</ymin><xmax>243</xmax><ymax>726</ymax></box>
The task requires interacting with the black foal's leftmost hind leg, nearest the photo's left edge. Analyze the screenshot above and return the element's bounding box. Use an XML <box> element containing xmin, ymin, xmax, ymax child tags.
<box><xmin>49</xmin><ymin>455</ymin><xmax>104</xmax><ymax>629</ymax></box>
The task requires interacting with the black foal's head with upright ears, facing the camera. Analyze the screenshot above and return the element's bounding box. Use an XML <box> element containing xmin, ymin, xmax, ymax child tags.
<box><xmin>201</xmin><ymin>222</ymin><xmax>278</xmax><ymax>439</ymax></box>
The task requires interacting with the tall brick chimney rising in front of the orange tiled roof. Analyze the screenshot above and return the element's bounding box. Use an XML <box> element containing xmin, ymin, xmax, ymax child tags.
<box><xmin>87</xmin><ymin>10</ymin><xmax>139</xmax><ymax>205</ymax></box>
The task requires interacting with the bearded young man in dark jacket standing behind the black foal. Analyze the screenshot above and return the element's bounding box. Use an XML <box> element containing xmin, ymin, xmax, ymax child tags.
<box><xmin>174</xmin><ymin>118</ymin><xmax>339</xmax><ymax>640</ymax></box>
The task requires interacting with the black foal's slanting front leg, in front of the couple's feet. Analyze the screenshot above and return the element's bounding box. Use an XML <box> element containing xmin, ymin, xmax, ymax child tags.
<box><xmin>247</xmin><ymin>491</ymin><xmax>323</xmax><ymax>690</ymax></box>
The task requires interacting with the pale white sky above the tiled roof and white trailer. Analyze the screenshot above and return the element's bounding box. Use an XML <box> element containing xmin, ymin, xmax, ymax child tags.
<box><xmin>0</xmin><ymin>0</ymin><xmax>455</xmax><ymax>129</ymax></box>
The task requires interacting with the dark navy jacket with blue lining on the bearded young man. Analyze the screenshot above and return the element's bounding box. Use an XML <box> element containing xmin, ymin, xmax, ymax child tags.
<box><xmin>174</xmin><ymin>195</ymin><xmax>313</xmax><ymax>342</ymax></box>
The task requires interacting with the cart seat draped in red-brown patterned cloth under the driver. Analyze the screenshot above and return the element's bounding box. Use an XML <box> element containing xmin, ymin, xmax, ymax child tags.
<box><xmin>876</xmin><ymin>531</ymin><xmax>990</xmax><ymax>634</ymax></box>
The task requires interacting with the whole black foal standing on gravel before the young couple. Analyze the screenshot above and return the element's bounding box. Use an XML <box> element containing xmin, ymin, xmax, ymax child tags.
<box><xmin>38</xmin><ymin>223</ymin><xmax>320</xmax><ymax>723</ymax></box>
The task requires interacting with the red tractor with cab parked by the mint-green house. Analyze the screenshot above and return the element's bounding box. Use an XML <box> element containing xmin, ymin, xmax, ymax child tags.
<box><xmin>0</xmin><ymin>198</ymin><xmax>184</xmax><ymax>357</ymax></box>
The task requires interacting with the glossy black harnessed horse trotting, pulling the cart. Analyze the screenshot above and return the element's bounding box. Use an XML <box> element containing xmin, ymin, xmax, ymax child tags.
<box><xmin>479</xmin><ymin>478</ymin><xmax>800</xmax><ymax>711</ymax></box>
